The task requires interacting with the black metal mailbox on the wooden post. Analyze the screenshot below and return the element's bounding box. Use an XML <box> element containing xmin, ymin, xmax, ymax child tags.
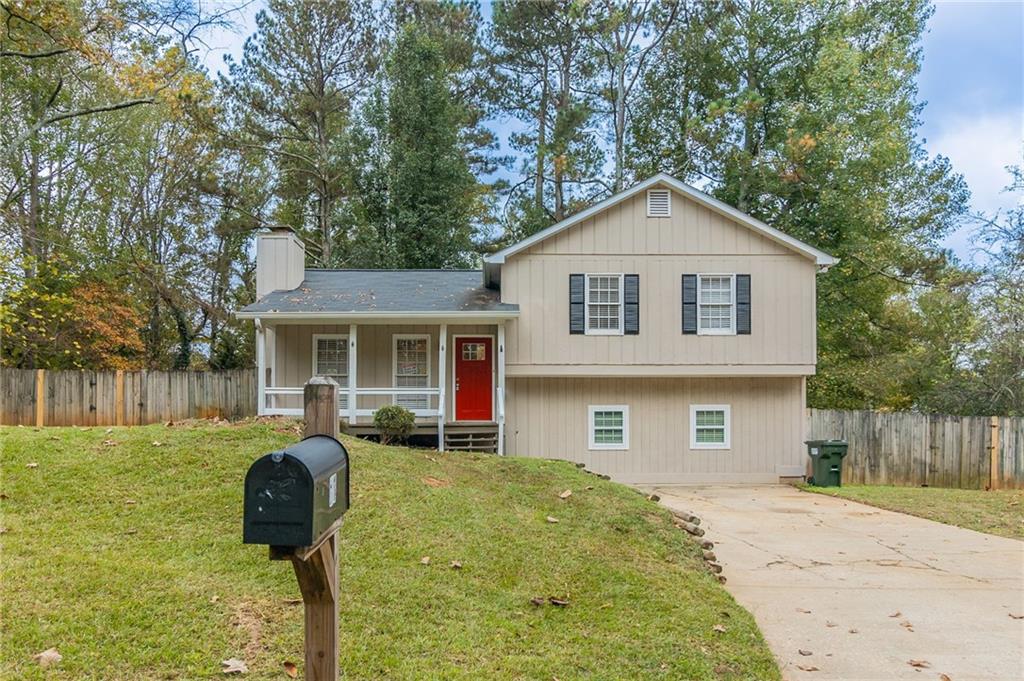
<box><xmin>243</xmin><ymin>435</ymin><xmax>348</xmax><ymax>547</ymax></box>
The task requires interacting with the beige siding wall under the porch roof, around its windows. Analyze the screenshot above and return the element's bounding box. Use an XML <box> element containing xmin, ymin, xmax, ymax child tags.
<box><xmin>267</xmin><ymin>325</ymin><xmax>497</xmax><ymax>421</ymax></box>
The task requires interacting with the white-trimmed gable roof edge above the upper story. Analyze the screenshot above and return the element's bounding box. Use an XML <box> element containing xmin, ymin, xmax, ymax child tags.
<box><xmin>484</xmin><ymin>173</ymin><xmax>837</xmax><ymax>266</ymax></box>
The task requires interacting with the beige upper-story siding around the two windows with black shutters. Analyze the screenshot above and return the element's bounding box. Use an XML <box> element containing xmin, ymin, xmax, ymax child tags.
<box><xmin>502</xmin><ymin>184</ymin><xmax>817</xmax><ymax>376</ymax></box>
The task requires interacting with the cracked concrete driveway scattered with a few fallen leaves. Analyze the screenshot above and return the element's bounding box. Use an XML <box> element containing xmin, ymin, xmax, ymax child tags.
<box><xmin>647</xmin><ymin>485</ymin><xmax>1024</xmax><ymax>681</ymax></box>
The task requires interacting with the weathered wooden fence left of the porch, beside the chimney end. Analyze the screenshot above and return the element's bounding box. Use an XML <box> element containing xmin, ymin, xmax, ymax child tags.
<box><xmin>0</xmin><ymin>368</ymin><xmax>256</xmax><ymax>426</ymax></box>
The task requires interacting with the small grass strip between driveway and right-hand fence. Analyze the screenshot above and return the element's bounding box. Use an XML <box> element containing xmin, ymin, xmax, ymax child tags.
<box><xmin>804</xmin><ymin>484</ymin><xmax>1024</xmax><ymax>539</ymax></box>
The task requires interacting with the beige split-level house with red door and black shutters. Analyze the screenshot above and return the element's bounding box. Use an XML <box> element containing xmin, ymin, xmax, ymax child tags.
<box><xmin>238</xmin><ymin>174</ymin><xmax>835</xmax><ymax>483</ymax></box>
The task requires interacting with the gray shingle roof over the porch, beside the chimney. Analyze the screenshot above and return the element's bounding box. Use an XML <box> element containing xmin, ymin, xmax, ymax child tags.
<box><xmin>240</xmin><ymin>269</ymin><xmax>519</xmax><ymax>315</ymax></box>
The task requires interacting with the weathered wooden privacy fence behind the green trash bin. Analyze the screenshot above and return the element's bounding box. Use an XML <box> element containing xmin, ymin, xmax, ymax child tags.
<box><xmin>807</xmin><ymin>409</ymin><xmax>1024</xmax><ymax>490</ymax></box>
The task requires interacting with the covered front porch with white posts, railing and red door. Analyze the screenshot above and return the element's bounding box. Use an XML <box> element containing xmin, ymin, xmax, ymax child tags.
<box><xmin>254</xmin><ymin>312</ymin><xmax>512</xmax><ymax>454</ymax></box>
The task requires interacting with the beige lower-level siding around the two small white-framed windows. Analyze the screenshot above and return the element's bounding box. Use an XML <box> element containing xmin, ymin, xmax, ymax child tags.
<box><xmin>505</xmin><ymin>377</ymin><xmax>807</xmax><ymax>483</ymax></box>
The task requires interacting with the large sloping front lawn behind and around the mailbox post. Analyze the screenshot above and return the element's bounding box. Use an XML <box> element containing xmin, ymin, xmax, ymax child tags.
<box><xmin>0</xmin><ymin>422</ymin><xmax>779</xmax><ymax>681</ymax></box>
